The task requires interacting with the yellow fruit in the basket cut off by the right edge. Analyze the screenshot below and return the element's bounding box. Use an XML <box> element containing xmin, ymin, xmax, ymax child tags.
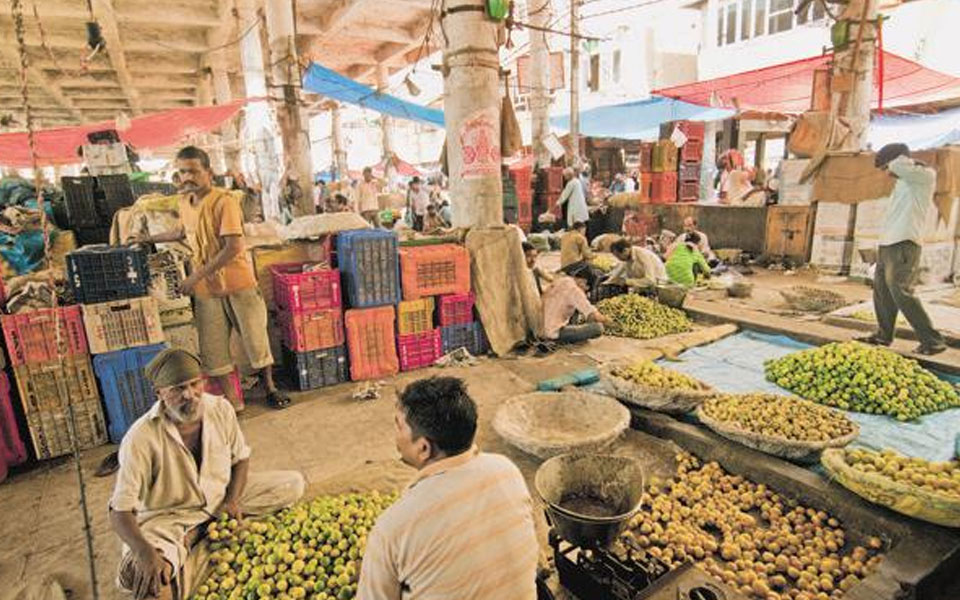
<box><xmin>844</xmin><ymin>448</ymin><xmax>960</xmax><ymax>499</ymax></box>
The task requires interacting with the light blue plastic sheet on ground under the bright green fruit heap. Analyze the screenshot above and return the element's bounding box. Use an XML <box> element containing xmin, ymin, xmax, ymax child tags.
<box><xmin>662</xmin><ymin>331</ymin><xmax>960</xmax><ymax>461</ymax></box>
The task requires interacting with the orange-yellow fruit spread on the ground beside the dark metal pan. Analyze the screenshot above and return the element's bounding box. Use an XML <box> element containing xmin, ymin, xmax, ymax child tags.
<box><xmin>613</xmin><ymin>453</ymin><xmax>884</xmax><ymax>600</ymax></box>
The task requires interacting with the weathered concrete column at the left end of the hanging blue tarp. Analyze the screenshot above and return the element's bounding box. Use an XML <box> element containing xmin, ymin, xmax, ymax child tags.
<box><xmin>264</xmin><ymin>0</ymin><xmax>314</xmax><ymax>215</ymax></box>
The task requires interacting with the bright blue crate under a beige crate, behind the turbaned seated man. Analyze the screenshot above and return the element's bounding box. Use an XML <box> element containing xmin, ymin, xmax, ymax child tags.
<box><xmin>93</xmin><ymin>344</ymin><xmax>167</xmax><ymax>444</ymax></box>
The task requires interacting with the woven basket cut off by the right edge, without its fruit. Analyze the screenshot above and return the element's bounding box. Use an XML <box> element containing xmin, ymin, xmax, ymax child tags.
<box><xmin>820</xmin><ymin>449</ymin><xmax>960</xmax><ymax>527</ymax></box>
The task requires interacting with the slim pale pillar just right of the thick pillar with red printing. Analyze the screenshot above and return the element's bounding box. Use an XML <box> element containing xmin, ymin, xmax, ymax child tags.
<box><xmin>527</xmin><ymin>0</ymin><xmax>553</xmax><ymax>167</ymax></box>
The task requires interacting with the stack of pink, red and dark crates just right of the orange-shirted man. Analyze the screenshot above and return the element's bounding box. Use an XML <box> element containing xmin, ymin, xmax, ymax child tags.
<box><xmin>270</xmin><ymin>263</ymin><xmax>347</xmax><ymax>390</ymax></box>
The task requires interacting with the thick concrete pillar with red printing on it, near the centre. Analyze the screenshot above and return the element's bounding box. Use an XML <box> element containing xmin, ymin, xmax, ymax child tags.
<box><xmin>441</xmin><ymin>0</ymin><xmax>503</xmax><ymax>227</ymax></box>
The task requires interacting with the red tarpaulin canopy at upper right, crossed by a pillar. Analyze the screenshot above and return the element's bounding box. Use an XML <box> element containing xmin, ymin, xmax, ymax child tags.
<box><xmin>653</xmin><ymin>51</ymin><xmax>960</xmax><ymax>113</ymax></box>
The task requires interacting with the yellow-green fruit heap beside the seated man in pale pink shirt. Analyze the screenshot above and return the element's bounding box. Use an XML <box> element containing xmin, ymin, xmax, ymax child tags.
<box><xmin>597</xmin><ymin>294</ymin><xmax>693</xmax><ymax>340</ymax></box>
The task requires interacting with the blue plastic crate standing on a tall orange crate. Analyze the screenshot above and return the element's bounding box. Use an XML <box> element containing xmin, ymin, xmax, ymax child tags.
<box><xmin>337</xmin><ymin>229</ymin><xmax>400</xmax><ymax>308</ymax></box>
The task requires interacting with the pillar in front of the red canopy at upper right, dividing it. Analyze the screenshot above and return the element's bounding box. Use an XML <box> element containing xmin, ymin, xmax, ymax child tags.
<box><xmin>830</xmin><ymin>0</ymin><xmax>877</xmax><ymax>151</ymax></box>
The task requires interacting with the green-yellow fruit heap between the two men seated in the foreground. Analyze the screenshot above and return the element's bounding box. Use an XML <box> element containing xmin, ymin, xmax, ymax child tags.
<box><xmin>192</xmin><ymin>492</ymin><xmax>397</xmax><ymax>600</ymax></box>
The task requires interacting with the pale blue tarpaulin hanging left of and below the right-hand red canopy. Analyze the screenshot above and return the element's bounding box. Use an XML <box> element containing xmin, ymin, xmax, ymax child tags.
<box><xmin>550</xmin><ymin>96</ymin><xmax>734</xmax><ymax>140</ymax></box>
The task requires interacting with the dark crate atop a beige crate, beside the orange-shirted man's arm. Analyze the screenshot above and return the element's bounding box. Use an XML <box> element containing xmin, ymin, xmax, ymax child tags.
<box><xmin>67</xmin><ymin>245</ymin><xmax>150</xmax><ymax>304</ymax></box>
